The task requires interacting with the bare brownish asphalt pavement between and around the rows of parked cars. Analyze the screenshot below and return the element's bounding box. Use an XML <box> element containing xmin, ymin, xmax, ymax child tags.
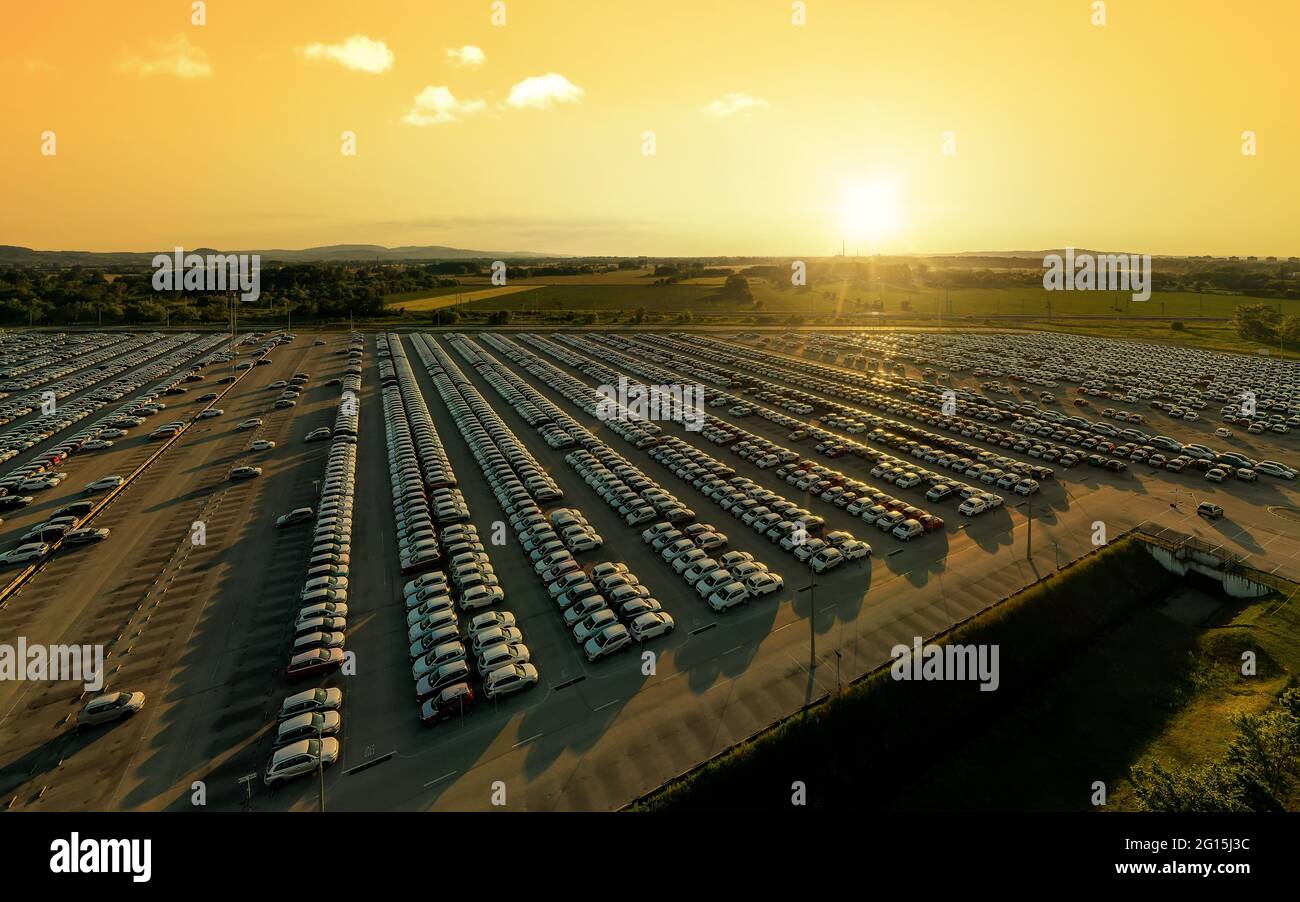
<box><xmin>0</xmin><ymin>333</ymin><xmax>1300</xmax><ymax>811</ymax></box>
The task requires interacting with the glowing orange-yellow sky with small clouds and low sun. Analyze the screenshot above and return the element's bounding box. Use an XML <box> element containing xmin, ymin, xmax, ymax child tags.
<box><xmin>0</xmin><ymin>0</ymin><xmax>1300</xmax><ymax>256</ymax></box>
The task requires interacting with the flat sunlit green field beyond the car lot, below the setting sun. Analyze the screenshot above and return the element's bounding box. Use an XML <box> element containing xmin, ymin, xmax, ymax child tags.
<box><xmin>374</xmin><ymin>279</ymin><xmax>1300</xmax><ymax>357</ymax></box>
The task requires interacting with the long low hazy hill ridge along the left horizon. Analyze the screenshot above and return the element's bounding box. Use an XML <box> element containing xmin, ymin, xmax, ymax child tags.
<box><xmin>0</xmin><ymin>244</ymin><xmax>564</xmax><ymax>266</ymax></box>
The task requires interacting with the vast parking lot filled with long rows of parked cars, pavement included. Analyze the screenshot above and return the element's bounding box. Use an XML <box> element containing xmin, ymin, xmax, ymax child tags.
<box><xmin>0</xmin><ymin>331</ymin><xmax>1300</xmax><ymax>810</ymax></box>
